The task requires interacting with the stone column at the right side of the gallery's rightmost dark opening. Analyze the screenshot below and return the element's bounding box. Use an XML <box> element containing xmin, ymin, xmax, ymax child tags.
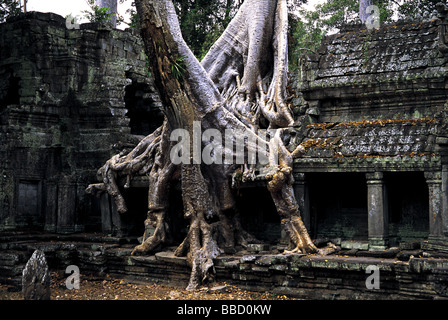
<box><xmin>425</xmin><ymin>172</ymin><xmax>446</xmax><ymax>239</ymax></box>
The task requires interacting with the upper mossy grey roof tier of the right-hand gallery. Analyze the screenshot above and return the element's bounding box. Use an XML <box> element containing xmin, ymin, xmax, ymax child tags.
<box><xmin>302</xmin><ymin>19</ymin><xmax>446</xmax><ymax>112</ymax></box>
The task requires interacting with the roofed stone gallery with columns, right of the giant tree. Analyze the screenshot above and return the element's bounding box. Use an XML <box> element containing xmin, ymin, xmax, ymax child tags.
<box><xmin>295</xmin><ymin>17</ymin><xmax>448</xmax><ymax>249</ymax></box>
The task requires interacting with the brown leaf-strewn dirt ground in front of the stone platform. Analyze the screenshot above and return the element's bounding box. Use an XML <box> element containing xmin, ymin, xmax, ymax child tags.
<box><xmin>0</xmin><ymin>274</ymin><xmax>300</xmax><ymax>300</ymax></box>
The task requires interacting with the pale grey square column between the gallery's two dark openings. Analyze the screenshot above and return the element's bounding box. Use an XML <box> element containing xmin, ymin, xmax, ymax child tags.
<box><xmin>366</xmin><ymin>172</ymin><xmax>389</xmax><ymax>251</ymax></box>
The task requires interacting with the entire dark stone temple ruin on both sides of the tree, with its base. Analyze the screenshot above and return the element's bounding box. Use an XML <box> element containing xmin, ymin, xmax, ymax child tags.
<box><xmin>0</xmin><ymin>12</ymin><xmax>448</xmax><ymax>299</ymax></box>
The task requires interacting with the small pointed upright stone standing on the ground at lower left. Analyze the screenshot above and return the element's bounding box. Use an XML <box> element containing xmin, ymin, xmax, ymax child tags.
<box><xmin>22</xmin><ymin>250</ymin><xmax>50</xmax><ymax>300</ymax></box>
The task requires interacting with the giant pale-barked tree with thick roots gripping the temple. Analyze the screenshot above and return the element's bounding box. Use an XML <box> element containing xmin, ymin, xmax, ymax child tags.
<box><xmin>88</xmin><ymin>0</ymin><xmax>335</xmax><ymax>289</ymax></box>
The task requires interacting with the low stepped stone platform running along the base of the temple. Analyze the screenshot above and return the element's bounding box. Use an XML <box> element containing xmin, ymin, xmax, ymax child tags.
<box><xmin>0</xmin><ymin>236</ymin><xmax>448</xmax><ymax>300</ymax></box>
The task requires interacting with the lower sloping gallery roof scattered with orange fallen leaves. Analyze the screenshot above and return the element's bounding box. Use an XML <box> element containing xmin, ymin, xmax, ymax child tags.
<box><xmin>303</xmin><ymin>119</ymin><xmax>437</xmax><ymax>159</ymax></box>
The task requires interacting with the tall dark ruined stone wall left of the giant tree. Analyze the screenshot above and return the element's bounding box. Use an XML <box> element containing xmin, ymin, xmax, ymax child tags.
<box><xmin>0</xmin><ymin>12</ymin><xmax>164</xmax><ymax>232</ymax></box>
